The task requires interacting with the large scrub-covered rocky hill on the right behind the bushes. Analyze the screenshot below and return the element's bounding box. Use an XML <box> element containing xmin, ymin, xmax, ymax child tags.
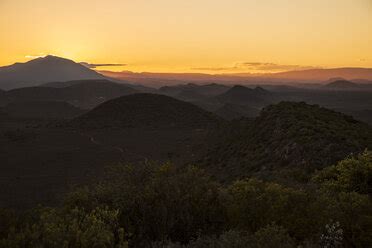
<box><xmin>202</xmin><ymin>102</ymin><xmax>372</xmax><ymax>180</ymax></box>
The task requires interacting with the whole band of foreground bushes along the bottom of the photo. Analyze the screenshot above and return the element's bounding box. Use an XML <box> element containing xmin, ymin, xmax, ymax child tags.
<box><xmin>0</xmin><ymin>151</ymin><xmax>372</xmax><ymax>248</ymax></box>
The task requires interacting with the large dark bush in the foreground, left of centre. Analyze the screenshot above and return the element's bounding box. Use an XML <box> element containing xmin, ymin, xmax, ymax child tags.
<box><xmin>67</xmin><ymin>163</ymin><xmax>226</xmax><ymax>247</ymax></box>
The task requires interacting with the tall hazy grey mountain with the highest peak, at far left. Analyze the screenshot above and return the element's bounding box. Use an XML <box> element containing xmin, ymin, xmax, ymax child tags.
<box><xmin>0</xmin><ymin>55</ymin><xmax>104</xmax><ymax>90</ymax></box>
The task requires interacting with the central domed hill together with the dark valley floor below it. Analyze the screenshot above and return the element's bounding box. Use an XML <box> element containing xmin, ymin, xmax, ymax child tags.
<box><xmin>0</xmin><ymin>94</ymin><xmax>220</xmax><ymax>209</ymax></box>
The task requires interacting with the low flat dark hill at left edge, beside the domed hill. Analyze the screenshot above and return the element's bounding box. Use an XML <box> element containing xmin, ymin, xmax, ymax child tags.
<box><xmin>3</xmin><ymin>101</ymin><xmax>84</xmax><ymax>119</ymax></box>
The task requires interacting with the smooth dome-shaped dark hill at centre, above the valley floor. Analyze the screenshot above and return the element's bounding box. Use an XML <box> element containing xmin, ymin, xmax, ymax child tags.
<box><xmin>70</xmin><ymin>93</ymin><xmax>220</xmax><ymax>128</ymax></box>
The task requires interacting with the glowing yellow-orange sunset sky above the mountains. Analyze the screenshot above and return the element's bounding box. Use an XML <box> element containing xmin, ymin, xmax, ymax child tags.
<box><xmin>0</xmin><ymin>0</ymin><xmax>372</xmax><ymax>73</ymax></box>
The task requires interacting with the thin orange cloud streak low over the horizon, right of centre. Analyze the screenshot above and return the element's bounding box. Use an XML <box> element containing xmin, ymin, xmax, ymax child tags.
<box><xmin>191</xmin><ymin>62</ymin><xmax>320</xmax><ymax>72</ymax></box>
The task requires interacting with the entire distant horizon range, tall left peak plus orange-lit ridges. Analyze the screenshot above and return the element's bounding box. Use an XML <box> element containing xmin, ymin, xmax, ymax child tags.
<box><xmin>0</xmin><ymin>55</ymin><xmax>372</xmax><ymax>90</ymax></box>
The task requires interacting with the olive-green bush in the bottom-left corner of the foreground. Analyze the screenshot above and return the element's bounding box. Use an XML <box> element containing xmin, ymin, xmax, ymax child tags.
<box><xmin>0</xmin><ymin>205</ymin><xmax>127</xmax><ymax>248</ymax></box>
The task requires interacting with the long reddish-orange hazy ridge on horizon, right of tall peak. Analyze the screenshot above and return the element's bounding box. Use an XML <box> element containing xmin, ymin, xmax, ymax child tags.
<box><xmin>99</xmin><ymin>68</ymin><xmax>372</xmax><ymax>86</ymax></box>
